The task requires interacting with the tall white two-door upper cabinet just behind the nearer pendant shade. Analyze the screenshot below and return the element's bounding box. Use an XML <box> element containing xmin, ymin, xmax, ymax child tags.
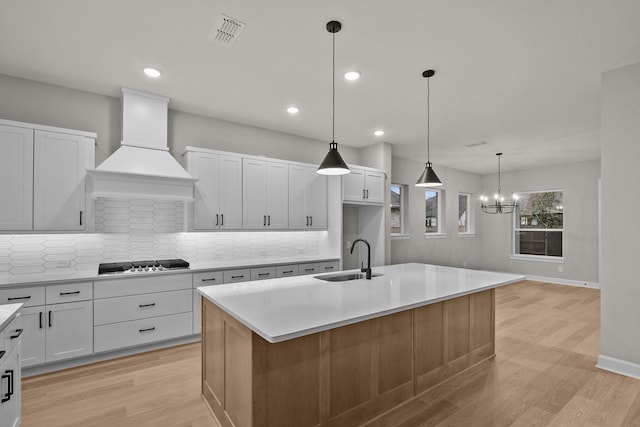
<box><xmin>289</xmin><ymin>165</ymin><xmax>328</xmax><ymax>230</ymax></box>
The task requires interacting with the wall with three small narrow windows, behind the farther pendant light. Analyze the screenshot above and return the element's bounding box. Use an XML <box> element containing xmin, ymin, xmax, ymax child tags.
<box><xmin>391</xmin><ymin>157</ymin><xmax>482</xmax><ymax>268</ymax></box>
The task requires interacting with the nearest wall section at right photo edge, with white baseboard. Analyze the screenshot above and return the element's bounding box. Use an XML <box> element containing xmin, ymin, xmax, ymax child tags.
<box><xmin>599</xmin><ymin>63</ymin><xmax>640</xmax><ymax>377</ymax></box>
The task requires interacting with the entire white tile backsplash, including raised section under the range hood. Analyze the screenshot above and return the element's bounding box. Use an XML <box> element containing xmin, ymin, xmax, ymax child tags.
<box><xmin>0</xmin><ymin>198</ymin><xmax>327</xmax><ymax>275</ymax></box>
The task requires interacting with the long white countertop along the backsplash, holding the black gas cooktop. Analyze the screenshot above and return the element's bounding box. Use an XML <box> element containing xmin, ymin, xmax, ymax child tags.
<box><xmin>0</xmin><ymin>255</ymin><xmax>339</xmax><ymax>288</ymax></box>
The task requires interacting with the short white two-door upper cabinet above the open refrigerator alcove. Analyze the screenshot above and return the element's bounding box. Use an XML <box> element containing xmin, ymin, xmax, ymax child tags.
<box><xmin>342</xmin><ymin>166</ymin><xmax>385</xmax><ymax>204</ymax></box>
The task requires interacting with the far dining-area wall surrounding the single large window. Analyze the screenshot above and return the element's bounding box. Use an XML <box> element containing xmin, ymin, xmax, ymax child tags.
<box><xmin>481</xmin><ymin>161</ymin><xmax>600</xmax><ymax>284</ymax></box>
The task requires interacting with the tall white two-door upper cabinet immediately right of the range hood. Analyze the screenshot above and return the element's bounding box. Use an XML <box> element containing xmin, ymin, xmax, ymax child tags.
<box><xmin>187</xmin><ymin>151</ymin><xmax>242</xmax><ymax>230</ymax></box>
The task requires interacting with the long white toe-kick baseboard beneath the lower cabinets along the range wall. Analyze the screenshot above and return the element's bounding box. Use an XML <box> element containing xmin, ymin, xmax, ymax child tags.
<box><xmin>22</xmin><ymin>334</ymin><xmax>200</xmax><ymax>378</ymax></box>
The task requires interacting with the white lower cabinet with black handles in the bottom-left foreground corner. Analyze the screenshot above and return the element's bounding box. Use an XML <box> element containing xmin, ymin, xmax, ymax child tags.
<box><xmin>0</xmin><ymin>313</ymin><xmax>23</xmax><ymax>427</ymax></box>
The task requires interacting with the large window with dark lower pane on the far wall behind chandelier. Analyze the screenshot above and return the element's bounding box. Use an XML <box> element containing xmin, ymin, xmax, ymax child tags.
<box><xmin>514</xmin><ymin>191</ymin><xmax>563</xmax><ymax>258</ymax></box>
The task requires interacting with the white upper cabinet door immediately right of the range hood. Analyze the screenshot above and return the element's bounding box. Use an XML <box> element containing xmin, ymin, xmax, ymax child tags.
<box><xmin>189</xmin><ymin>153</ymin><xmax>220</xmax><ymax>230</ymax></box>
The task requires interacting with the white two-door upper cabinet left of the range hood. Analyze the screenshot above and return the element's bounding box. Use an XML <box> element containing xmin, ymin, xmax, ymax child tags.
<box><xmin>0</xmin><ymin>120</ymin><xmax>95</xmax><ymax>231</ymax></box>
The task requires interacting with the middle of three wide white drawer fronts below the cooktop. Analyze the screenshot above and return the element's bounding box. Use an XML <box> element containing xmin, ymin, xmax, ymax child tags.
<box><xmin>93</xmin><ymin>289</ymin><xmax>193</xmax><ymax>325</ymax></box>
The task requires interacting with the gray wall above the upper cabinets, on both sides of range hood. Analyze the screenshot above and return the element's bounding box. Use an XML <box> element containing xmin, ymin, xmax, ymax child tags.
<box><xmin>0</xmin><ymin>74</ymin><xmax>359</xmax><ymax>166</ymax></box>
